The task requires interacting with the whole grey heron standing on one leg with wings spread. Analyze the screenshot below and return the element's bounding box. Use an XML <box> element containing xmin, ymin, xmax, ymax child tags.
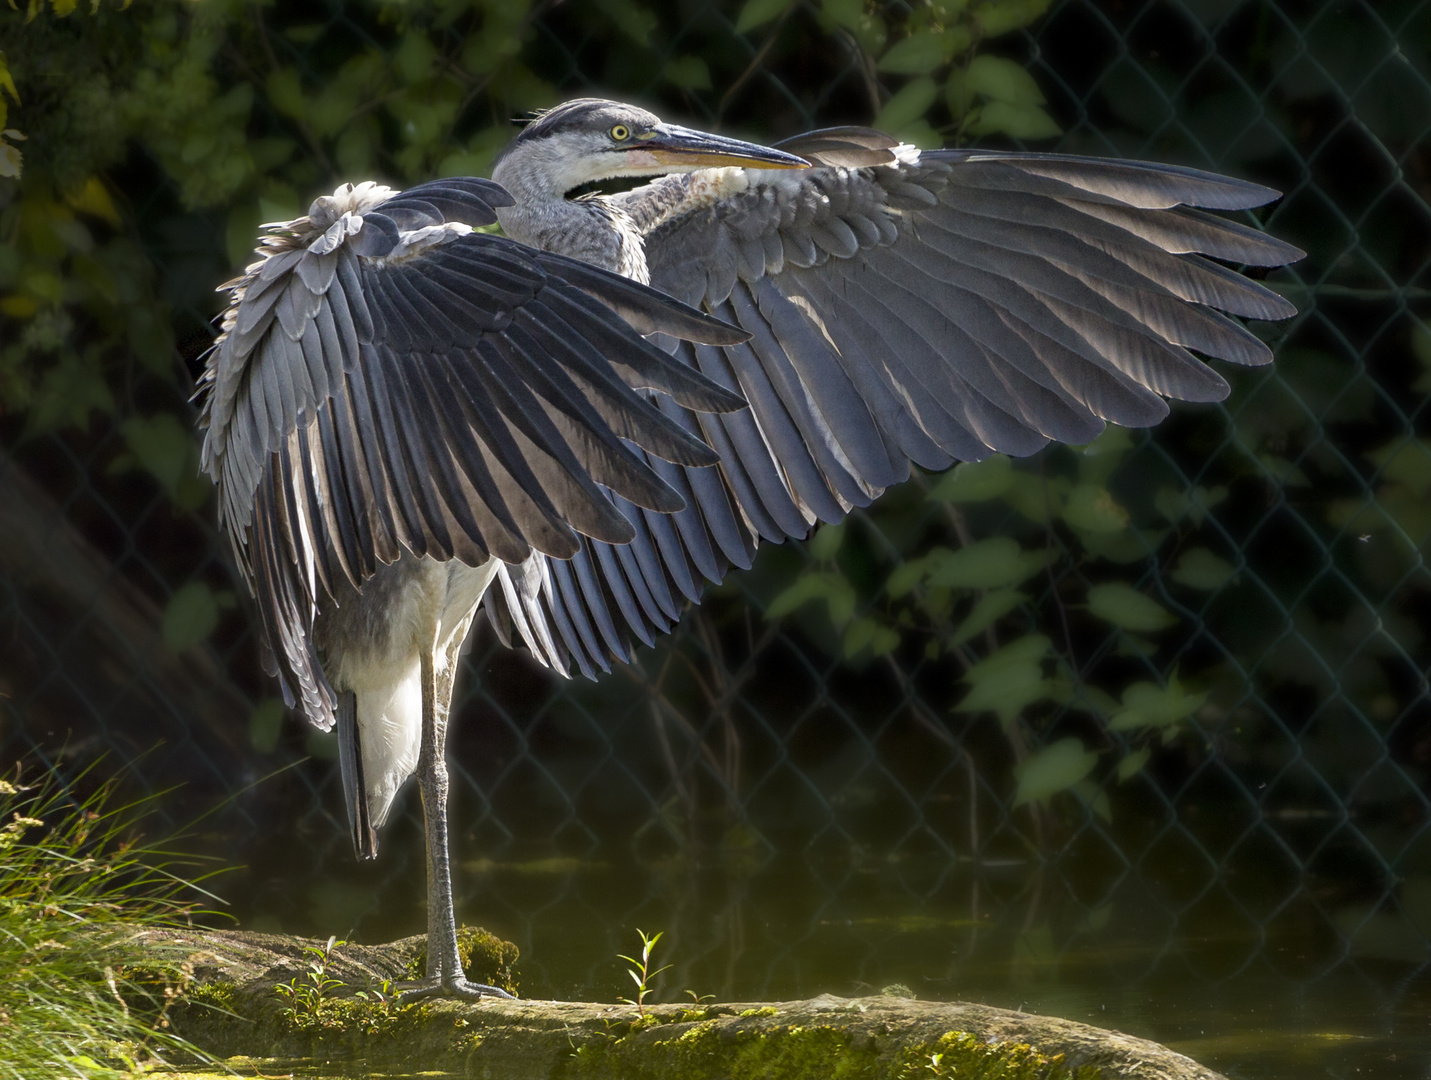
<box><xmin>202</xmin><ymin>99</ymin><xmax>1301</xmax><ymax>997</ymax></box>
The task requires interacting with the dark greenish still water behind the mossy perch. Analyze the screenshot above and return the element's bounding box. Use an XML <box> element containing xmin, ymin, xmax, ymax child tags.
<box><xmin>220</xmin><ymin>845</ymin><xmax>1431</xmax><ymax>1080</ymax></box>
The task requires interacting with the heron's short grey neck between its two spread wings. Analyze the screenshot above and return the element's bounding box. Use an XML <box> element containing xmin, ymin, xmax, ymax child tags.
<box><xmin>492</xmin><ymin>153</ymin><xmax>651</xmax><ymax>285</ymax></box>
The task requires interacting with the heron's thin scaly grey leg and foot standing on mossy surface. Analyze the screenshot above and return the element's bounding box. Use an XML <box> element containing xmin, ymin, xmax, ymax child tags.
<box><xmin>402</xmin><ymin>641</ymin><xmax>511</xmax><ymax>1000</ymax></box>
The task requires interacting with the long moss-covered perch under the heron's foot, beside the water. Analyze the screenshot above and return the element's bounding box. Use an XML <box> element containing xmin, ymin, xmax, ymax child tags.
<box><xmin>114</xmin><ymin>931</ymin><xmax>1221</xmax><ymax>1080</ymax></box>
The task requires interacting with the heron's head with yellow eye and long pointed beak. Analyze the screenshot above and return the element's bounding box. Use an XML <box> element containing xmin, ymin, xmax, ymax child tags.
<box><xmin>492</xmin><ymin>97</ymin><xmax>809</xmax><ymax>195</ymax></box>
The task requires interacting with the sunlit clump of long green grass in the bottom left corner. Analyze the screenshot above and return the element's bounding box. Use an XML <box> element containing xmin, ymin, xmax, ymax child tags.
<box><xmin>0</xmin><ymin>775</ymin><xmax>220</xmax><ymax>1080</ymax></box>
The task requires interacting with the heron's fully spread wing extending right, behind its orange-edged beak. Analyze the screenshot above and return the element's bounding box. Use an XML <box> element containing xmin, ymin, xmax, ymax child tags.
<box><xmin>475</xmin><ymin>140</ymin><xmax>1301</xmax><ymax>674</ymax></box>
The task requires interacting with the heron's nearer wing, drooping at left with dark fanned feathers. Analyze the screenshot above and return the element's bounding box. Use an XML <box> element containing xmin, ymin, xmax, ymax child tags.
<box><xmin>200</xmin><ymin>180</ymin><xmax>746</xmax><ymax>730</ymax></box>
